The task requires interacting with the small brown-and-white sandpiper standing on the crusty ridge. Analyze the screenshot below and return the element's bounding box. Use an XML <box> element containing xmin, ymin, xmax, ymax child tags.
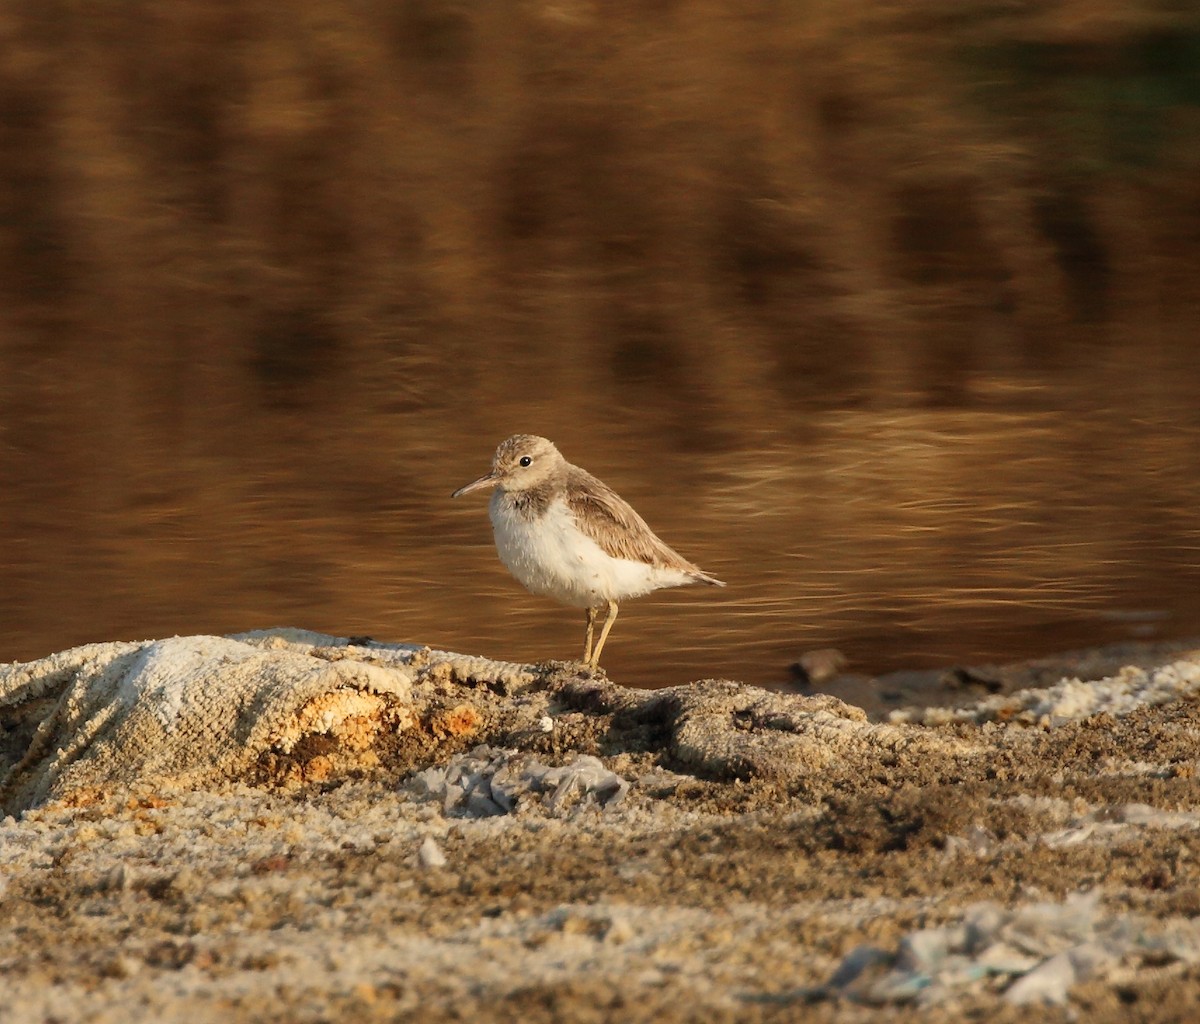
<box><xmin>451</xmin><ymin>433</ymin><xmax>725</xmax><ymax>666</ymax></box>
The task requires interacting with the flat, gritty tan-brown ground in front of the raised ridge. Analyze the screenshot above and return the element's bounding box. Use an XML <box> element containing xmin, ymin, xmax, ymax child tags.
<box><xmin>0</xmin><ymin>703</ymin><xmax>1200</xmax><ymax>1022</ymax></box>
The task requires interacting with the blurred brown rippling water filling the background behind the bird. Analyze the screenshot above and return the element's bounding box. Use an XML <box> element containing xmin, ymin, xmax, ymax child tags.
<box><xmin>0</xmin><ymin>0</ymin><xmax>1200</xmax><ymax>685</ymax></box>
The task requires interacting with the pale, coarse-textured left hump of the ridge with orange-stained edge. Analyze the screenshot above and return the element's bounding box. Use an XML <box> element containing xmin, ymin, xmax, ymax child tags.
<box><xmin>0</xmin><ymin>629</ymin><xmax>534</xmax><ymax>813</ymax></box>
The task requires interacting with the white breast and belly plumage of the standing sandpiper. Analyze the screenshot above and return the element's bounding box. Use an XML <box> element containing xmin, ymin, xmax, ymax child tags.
<box><xmin>488</xmin><ymin>491</ymin><xmax>692</xmax><ymax>607</ymax></box>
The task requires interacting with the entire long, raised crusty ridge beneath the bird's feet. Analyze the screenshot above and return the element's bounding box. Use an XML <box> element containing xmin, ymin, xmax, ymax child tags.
<box><xmin>0</xmin><ymin>630</ymin><xmax>967</xmax><ymax>813</ymax></box>
